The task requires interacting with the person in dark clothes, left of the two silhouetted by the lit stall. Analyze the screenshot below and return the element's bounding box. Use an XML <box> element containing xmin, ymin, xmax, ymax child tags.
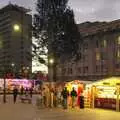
<box><xmin>61</xmin><ymin>87</ymin><xmax>69</xmax><ymax>109</ymax></box>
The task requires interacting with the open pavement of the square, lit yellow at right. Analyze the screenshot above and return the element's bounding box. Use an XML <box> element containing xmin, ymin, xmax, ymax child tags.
<box><xmin>0</xmin><ymin>96</ymin><xmax>120</xmax><ymax>120</ymax></box>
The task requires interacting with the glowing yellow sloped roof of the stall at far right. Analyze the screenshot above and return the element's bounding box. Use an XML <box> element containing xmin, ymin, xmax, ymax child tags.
<box><xmin>88</xmin><ymin>77</ymin><xmax>120</xmax><ymax>86</ymax></box>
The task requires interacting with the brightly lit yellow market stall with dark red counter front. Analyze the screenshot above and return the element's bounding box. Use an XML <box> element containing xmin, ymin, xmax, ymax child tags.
<box><xmin>86</xmin><ymin>77</ymin><xmax>120</xmax><ymax>111</ymax></box>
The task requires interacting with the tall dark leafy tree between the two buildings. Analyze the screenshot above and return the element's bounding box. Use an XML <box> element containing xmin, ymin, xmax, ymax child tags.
<box><xmin>33</xmin><ymin>0</ymin><xmax>80</xmax><ymax>63</ymax></box>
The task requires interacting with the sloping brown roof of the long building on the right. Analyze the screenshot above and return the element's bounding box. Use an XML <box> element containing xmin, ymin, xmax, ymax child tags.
<box><xmin>78</xmin><ymin>19</ymin><xmax>120</xmax><ymax>36</ymax></box>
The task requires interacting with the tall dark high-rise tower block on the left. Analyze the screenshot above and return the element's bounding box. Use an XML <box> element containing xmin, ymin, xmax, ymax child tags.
<box><xmin>0</xmin><ymin>4</ymin><xmax>32</xmax><ymax>72</ymax></box>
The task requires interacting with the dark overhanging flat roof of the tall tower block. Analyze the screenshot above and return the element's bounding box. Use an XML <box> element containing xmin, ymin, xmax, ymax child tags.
<box><xmin>0</xmin><ymin>3</ymin><xmax>31</xmax><ymax>13</ymax></box>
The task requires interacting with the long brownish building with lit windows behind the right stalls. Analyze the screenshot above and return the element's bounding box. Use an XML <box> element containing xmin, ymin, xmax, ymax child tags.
<box><xmin>57</xmin><ymin>20</ymin><xmax>120</xmax><ymax>81</ymax></box>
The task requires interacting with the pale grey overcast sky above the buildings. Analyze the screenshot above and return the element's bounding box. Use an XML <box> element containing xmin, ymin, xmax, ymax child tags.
<box><xmin>0</xmin><ymin>0</ymin><xmax>120</xmax><ymax>23</ymax></box>
